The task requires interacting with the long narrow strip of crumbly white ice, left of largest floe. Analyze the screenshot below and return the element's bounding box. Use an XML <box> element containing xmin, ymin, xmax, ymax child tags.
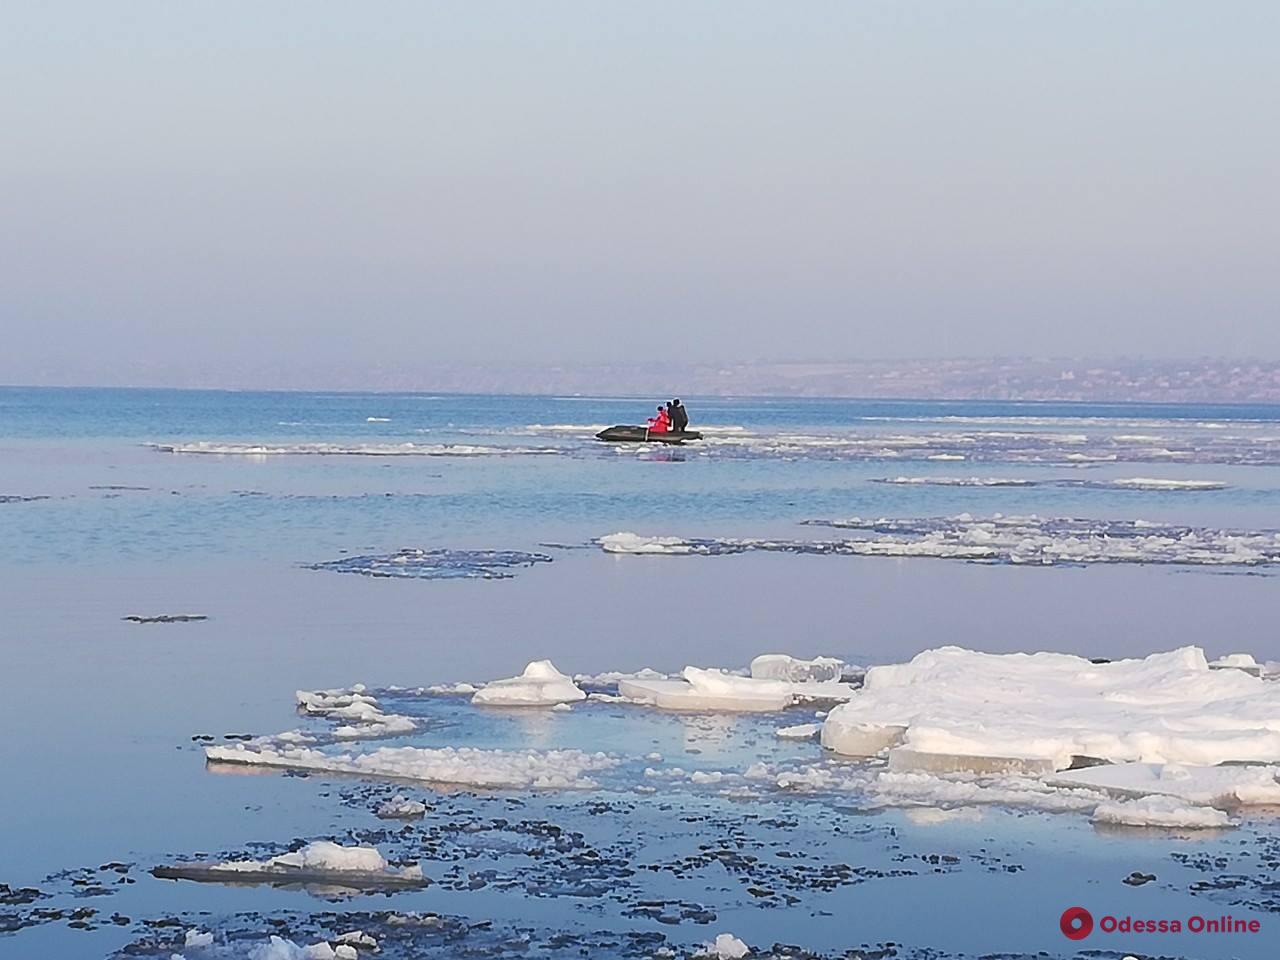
<box><xmin>205</xmin><ymin>744</ymin><xmax>618</xmax><ymax>790</ymax></box>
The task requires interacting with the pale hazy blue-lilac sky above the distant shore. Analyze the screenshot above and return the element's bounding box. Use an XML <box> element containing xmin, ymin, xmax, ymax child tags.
<box><xmin>0</xmin><ymin>0</ymin><xmax>1280</xmax><ymax>387</ymax></box>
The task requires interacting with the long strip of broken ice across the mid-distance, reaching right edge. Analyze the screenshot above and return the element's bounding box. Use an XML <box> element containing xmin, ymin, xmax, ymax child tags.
<box><xmin>598</xmin><ymin>513</ymin><xmax>1280</xmax><ymax>567</ymax></box>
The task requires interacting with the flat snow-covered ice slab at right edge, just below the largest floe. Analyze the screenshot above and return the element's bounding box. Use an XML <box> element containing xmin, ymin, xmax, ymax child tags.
<box><xmin>1048</xmin><ymin>763</ymin><xmax>1280</xmax><ymax>808</ymax></box>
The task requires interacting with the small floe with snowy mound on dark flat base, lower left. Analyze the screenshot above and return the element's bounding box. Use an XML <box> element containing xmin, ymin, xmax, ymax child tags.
<box><xmin>152</xmin><ymin>840</ymin><xmax>429</xmax><ymax>887</ymax></box>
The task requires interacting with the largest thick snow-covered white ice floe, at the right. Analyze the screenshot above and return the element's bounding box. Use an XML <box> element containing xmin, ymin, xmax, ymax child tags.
<box><xmin>822</xmin><ymin>646</ymin><xmax>1280</xmax><ymax>773</ymax></box>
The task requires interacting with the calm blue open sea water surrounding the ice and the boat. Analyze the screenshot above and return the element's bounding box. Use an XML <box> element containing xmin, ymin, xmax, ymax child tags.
<box><xmin>0</xmin><ymin>388</ymin><xmax>1280</xmax><ymax>957</ymax></box>
